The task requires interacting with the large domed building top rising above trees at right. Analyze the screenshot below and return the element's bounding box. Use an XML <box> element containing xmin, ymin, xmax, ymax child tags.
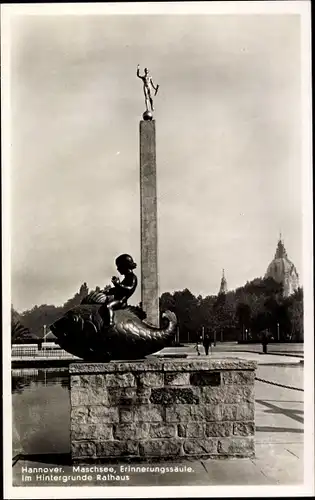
<box><xmin>265</xmin><ymin>235</ymin><xmax>299</xmax><ymax>297</ymax></box>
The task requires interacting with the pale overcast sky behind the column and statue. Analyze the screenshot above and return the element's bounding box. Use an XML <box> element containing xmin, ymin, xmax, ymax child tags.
<box><xmin>11</xmin><ymin>9</ymin><xmax>302</xmax><ymax>310</ymax></box>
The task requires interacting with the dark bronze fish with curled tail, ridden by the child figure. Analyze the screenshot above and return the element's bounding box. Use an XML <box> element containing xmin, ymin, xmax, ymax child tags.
<box><xmin>50</xmin><ymin>292</ymin><xmax>177</xmax><ymax>362</ymax></box>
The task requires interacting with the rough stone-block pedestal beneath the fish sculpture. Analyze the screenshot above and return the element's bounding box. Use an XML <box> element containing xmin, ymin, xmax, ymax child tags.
<box><xmin>69</xmin><ymin>358</ymin><xmax>256</xmax><ymax>462</ymax></box>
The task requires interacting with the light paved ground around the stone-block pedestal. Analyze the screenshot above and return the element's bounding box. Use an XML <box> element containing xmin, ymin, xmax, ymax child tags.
<box><xmin>13</xmin><ymin>344</ymin><xmax>304</xmax><ymax>486</ymax></box>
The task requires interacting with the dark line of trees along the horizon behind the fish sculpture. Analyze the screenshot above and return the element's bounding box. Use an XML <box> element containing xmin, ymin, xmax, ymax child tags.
<box><xmin>11</xmin><ymin>278</ymin><xmax>304</xmax><ymax>343</ymax></box>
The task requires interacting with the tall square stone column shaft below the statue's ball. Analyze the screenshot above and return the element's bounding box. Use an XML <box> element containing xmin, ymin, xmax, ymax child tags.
<box><xmin>140</xmin><ymin>115</ymin><xmax>159</xmax><ymax>326</ymax></box>
